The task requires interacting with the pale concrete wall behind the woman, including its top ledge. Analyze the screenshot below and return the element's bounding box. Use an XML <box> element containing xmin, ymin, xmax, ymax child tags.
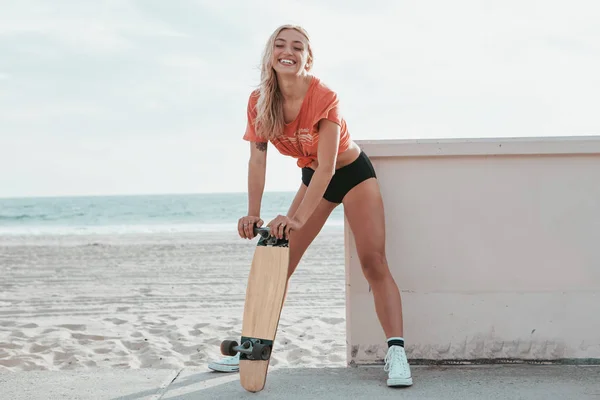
<box><xmin>344</xmin><ymin>136</ymin><xmax>600</xmax><ymax>364</ymax></box>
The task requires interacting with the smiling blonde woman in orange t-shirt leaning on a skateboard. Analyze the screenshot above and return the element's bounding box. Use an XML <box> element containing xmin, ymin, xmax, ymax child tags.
<box><xmin>209</xmin><ymin>25</ymin><xmax>412</xmax><ymax>386</ymax></box>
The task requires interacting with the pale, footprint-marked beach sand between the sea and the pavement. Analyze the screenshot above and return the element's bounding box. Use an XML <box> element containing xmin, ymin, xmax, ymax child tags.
<box><xmin>0</xmin><ymin>228</ymin><xmax>346</xmax><ymax>372</ymax></box>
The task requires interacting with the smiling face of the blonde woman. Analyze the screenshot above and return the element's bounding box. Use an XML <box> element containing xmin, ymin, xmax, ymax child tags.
<box><xmin>271</xmin><ymin>29</ymin><xmax>312</xmax><ymax>75</ymax></box>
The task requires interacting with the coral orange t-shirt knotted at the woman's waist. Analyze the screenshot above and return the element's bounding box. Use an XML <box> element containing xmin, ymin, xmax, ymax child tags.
<box><xmin>243</xmin><ymin>76</ymin><xmax>351</xmax><ymax>168</ymax></box>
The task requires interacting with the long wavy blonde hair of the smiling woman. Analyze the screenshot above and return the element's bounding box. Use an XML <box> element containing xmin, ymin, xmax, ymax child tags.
<box><xmin>256</xmin><ymin>24</ymin><xmax>313</xmax><ymax>140</ymax></box>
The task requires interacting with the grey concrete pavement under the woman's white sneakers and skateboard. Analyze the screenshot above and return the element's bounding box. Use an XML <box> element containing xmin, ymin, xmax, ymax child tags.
<box><xmin>0</xmin><ymin>364</ymin><xmax>600</xmax><ymax>400</ymax></box>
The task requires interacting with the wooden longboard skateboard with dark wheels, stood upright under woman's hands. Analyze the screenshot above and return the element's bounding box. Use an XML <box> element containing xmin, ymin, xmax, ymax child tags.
<box><xmin>221</xmin><ymin>227</ymin><xmax>289</xmax><ymax>392</ymax></box>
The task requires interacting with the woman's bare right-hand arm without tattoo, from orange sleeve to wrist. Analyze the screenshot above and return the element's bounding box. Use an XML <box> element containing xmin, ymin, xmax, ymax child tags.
<box><xmin>292</xmin><ymin>119</ymin><xmax>340</xmax><ymax>224</ymax></box>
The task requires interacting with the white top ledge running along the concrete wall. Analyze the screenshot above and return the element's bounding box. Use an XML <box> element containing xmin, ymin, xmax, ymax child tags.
<box><xmin>354</xmin><ymin>135</ymin><xmax>600</xmax><ymax>157</ymax></box>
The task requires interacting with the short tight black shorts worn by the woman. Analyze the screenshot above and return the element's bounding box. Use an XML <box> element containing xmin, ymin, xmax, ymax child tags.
<box><xmin>302</xmin><ymin>150</ymin><xmax>377</xmax><ymax>204</ymax></box>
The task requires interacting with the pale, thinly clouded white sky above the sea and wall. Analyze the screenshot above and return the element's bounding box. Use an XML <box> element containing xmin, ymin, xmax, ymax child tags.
<box><xmin>0</xmin><ymin>0</ymin><xmax>600</xmax><ymax>197</ymax></box>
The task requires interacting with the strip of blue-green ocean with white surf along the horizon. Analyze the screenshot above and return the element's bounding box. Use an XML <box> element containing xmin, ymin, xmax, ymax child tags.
<box><xmin>0</xmin><ymin>192</ymin><xmax>344</xmax><ymax>235</ymax></box>
